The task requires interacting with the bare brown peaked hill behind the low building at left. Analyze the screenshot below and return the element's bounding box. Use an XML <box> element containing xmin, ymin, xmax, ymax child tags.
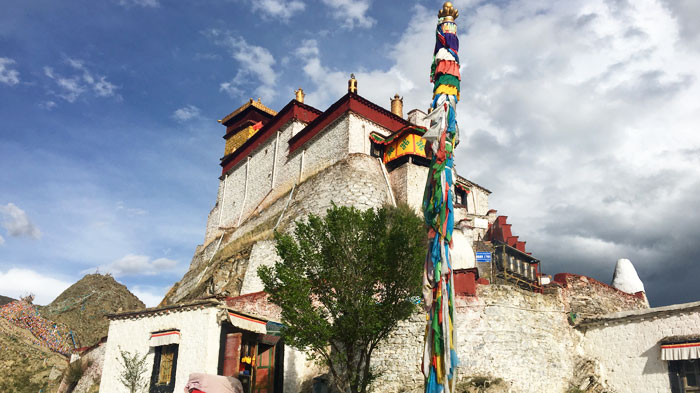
<box><xmin>40</xmin><ymin>274</ymin><xmax>146</xmax><ymax>347</ymax></box>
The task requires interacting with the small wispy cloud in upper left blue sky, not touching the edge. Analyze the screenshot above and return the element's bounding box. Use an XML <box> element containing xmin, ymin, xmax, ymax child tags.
<box><xmin>44</xmin><ymin>58</ymin><xmax>117</xmax><ymax>102</ymax></box>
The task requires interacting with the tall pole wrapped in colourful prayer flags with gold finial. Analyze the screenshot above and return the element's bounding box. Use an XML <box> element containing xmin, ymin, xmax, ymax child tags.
<box><xmin>422</xmin><ymin>1</ymin><xmax>460</xmax><ymax>393</ymax></box>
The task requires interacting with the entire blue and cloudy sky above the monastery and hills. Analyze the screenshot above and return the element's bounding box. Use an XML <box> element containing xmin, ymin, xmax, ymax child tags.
<box><xmin>0</xmin><ymin>0</ymin><xmax>700</xmax><ymax>306</ymax></box>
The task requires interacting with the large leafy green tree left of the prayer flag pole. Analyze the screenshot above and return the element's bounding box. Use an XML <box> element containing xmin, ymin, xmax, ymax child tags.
<box><xmin>258</xmin><ymin>205</ymin><xmax>426</xmax><ymax>393</ymax></box>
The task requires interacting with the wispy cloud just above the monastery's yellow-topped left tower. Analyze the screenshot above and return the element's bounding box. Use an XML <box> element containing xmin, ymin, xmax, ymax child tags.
<box><xmin>207</xmin><ymin>29</ymin><xmax>277</xmax><ymax>100</ymax></box>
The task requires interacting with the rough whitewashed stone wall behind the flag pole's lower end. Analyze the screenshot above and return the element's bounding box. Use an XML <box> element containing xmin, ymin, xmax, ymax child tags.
<box><xmin>373</xmin><ymin>285</ymin><xmax>579</xmax><ymax>393</ymax></box>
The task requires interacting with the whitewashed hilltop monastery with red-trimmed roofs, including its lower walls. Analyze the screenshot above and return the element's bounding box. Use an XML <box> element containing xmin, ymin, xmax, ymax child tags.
<box><xmin>100</xmin><ymin>82</ymin><xmax>700</xmax><ymax>393</ymax></box>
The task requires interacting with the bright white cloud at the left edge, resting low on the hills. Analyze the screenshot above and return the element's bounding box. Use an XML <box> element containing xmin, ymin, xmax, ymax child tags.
<box><xmin>0</xmin><ymin>268</ymin><xmax>72</xmax><ymax>305</ymax></box>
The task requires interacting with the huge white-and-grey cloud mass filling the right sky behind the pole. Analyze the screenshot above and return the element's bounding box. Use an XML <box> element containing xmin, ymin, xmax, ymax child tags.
<box><xmin>295</xmin><ymin>0</ymin><xmax>700</xmax><ymax>302</ymax></box>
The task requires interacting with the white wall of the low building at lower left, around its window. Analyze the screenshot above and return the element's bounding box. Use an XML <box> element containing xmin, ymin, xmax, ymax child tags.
<box><xmin>100</xmin><ymin>307</ymin><xmax>221</xmax><ymax>393</ymax></box>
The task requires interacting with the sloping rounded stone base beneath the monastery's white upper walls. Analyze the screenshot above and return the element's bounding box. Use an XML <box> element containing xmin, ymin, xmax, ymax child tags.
<box><xmin>164</xmin><ymin>154</ymin><xmax>390</xmax><ymax>304</ymax></box>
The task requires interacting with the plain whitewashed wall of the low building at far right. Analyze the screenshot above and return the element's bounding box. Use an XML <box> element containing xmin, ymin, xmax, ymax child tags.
<box><xmin>578</xmin><ymin>302</ymin><xmax>700</xmax><ymax>393</ymax></box>
